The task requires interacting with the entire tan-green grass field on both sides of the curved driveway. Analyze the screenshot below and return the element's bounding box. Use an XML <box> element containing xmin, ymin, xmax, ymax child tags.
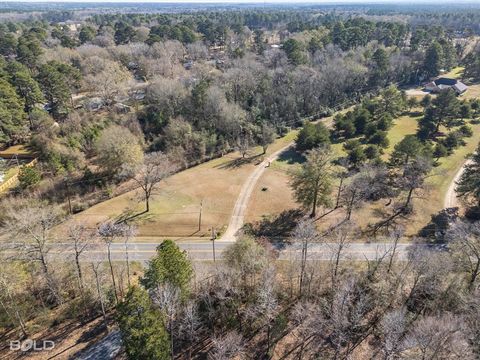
<box><xmin>64</xmin><ymin>77</ymin><xmax>480</xmax><ymax>241</ymax></box>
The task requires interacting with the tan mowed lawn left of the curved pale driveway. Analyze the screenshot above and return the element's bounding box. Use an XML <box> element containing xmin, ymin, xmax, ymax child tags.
<box><xmin>68</xmin><ymin>131</ymin><xmax>296</xmax><ymax>241</ymax></box>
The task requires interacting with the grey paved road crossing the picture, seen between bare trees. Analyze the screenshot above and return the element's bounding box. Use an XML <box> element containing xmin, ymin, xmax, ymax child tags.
<box><xmin>0</xmin><ymin>240</ymin><xmax>420</xmax><ymax>262</ymax></box>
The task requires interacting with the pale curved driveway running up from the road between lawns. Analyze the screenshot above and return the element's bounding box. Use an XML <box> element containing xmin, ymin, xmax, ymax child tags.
<box><xmin>219</xmin><ymin>142</ymin><xmax>293</xmax><ymax>241</ymax></box>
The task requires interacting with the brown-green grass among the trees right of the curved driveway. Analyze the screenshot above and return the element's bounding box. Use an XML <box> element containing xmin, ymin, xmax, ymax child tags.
<box><xmin>246</xmin><ymin>98</ymin><xmax>480</xmax><ymax>236</ymax></box>
